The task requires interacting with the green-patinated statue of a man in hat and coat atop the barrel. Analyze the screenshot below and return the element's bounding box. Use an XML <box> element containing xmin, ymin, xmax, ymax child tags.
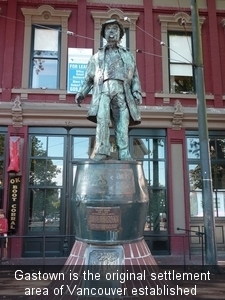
<box><xmin>75</xmin><ymin>20</ymin><xmax>142</xmax><ymax>161</ymax></box>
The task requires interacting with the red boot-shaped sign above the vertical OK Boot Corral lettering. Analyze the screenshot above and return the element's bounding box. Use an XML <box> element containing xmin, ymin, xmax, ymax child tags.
<box><xmin>7</xmin><ymin>136</ymin><xmax>20</xmax><ymax>173</ymax></box>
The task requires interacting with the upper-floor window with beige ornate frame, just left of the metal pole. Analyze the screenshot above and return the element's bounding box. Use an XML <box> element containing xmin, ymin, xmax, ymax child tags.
<box><xmin>156</xmin><ymin>12</ymin><xmax>205</xmax><ymax>103</ymax></box>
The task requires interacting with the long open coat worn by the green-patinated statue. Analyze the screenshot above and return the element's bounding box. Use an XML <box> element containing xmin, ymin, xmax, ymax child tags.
<box><xmin>79</xmin><ymin>46</ymin><xmax>141</xmax><ymax>125</ymax></box>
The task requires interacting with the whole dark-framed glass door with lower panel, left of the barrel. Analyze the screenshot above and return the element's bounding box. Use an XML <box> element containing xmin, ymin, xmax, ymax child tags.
<box><xmin>24</xmin><ymin>129</ymin><xmax>67</xmax><ymax>256</ymax></box>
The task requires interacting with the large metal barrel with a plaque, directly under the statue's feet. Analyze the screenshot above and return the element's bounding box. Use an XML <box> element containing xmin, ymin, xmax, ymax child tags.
<box><xmin>72</xmin><ymin>160</ymin><xmax>149</xmax><ymax>245</ymax></box>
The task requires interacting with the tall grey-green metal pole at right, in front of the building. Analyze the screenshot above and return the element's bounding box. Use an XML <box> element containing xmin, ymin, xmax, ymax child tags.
<box><xmin>191</xmin><ymin>0</ymin><xmax>218</xmax><ymax>267</ymax></box>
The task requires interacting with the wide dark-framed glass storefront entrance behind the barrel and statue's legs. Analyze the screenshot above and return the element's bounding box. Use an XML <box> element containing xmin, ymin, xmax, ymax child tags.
<box><xmin>23</xmin><ymin>128</ymin><xmax>169</xmax><ymax>257</ymax></box>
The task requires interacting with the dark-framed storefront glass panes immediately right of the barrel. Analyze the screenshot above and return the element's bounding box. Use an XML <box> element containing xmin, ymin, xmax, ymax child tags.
<box><xmin>132</xmin><ymin>138</ymin><xmax>167</xmax><ymax>232</ymax></box>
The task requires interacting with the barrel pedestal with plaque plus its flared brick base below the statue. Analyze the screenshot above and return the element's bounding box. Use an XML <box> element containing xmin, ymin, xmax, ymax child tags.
<box><xmin>32</xmin><ymin>160</ymin><xmax>192</xmax><ymax>300</ymax></box>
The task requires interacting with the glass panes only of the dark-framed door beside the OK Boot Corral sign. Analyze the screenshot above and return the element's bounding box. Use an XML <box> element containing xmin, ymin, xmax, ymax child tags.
<box><xmin>28</xmin><ymin>134</ymin><xmax>65</xmax><ymax>233</ymax></box>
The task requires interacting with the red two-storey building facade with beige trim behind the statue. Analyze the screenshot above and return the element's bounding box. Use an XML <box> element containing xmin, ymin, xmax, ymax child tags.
<box><xmin>0</xmin><ymin>0</ymin><xmax>225</xmax><ymax>257</ymax></box>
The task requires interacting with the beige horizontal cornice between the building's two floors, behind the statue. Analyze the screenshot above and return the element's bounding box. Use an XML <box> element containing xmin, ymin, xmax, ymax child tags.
<box><xmin>0</xmin><ymin>98</ymin><xmax>225</xmax><ymax>130</ymax></box>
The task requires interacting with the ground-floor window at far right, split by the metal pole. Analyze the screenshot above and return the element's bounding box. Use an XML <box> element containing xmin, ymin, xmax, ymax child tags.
<box><xmin>187</xmin><ymin>133</ymin><xmax>225</xmax><ymax>217</ymax></box>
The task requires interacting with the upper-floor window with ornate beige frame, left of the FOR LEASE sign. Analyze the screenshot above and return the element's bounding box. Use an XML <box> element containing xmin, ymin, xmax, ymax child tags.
<box><xmin>21</xmin><ymin>5</ymin><xmax>71</xmax><ymax>93</ymax></box>
